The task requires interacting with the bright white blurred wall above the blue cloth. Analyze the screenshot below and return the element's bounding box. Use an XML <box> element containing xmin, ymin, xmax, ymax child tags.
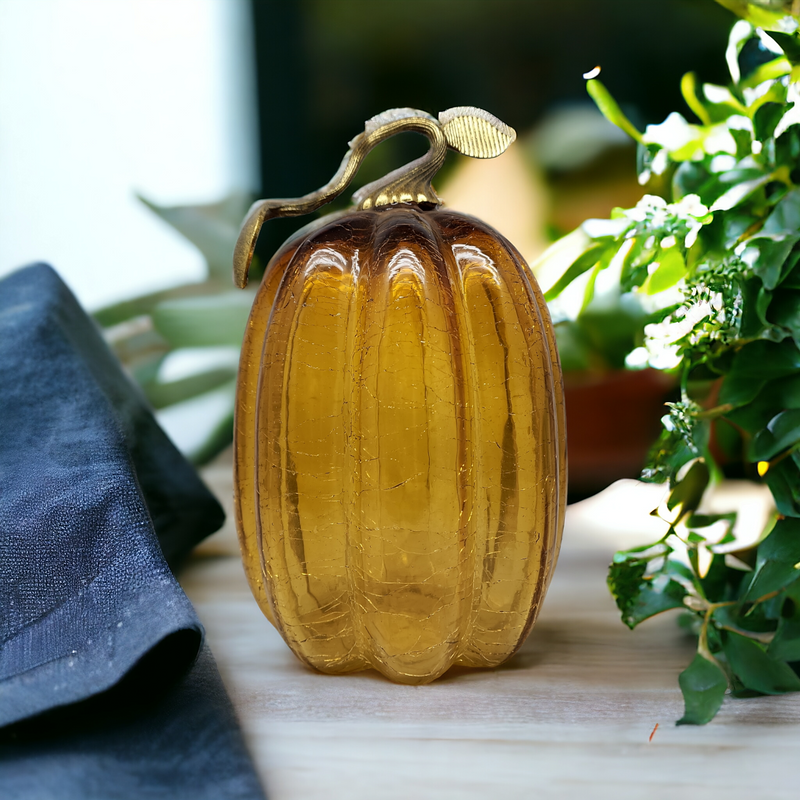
<box><xmin>0</xmin><ymin>0</ymin><xmax>258</xmax><ymax>308</ymax></box>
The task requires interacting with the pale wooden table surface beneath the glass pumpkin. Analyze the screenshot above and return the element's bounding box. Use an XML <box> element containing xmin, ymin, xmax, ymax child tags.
<box><xmin>184</xmin><ymin>461</ymin><xmax>800</xmax><ymax>800</ymax></box>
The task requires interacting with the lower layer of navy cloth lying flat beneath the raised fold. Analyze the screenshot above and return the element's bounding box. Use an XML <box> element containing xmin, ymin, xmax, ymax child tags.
<box><xmin>0</xmin><ymin>646</ymin><xmax>264</xmax><ymax>800</ymax></box>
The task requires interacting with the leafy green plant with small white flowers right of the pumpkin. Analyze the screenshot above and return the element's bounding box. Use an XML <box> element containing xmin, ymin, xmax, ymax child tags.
<box><xmin>540</xmin><ymin>0</ymin><xmax>800</xmax><ymax>724</ymax></box>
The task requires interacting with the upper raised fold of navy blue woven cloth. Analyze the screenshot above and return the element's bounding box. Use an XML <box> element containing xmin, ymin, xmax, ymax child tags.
<box><xmin>0</xmin><ymin>264</ymin><xmax>260</xmax><ymax>797</ymax></box>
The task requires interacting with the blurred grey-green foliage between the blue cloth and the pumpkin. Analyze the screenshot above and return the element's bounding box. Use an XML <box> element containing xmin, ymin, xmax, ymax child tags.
<box><xmin>94</xmin><ymin>194</ymin><xmax>258</xmax><ymax>464</ymax></box>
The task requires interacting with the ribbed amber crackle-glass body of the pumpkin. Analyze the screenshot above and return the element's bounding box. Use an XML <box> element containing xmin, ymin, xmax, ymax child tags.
<box><xmin>235</xmin><ymin>109</ymin><xmax>566</xmax><ymax>683</ymax></box>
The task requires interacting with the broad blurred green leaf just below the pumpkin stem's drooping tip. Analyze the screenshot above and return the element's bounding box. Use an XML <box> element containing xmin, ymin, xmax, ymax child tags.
<box><xmin>152</xmin><ymin>291</ymin><xmax>253</xmax><ymax>347</ymax></box>
